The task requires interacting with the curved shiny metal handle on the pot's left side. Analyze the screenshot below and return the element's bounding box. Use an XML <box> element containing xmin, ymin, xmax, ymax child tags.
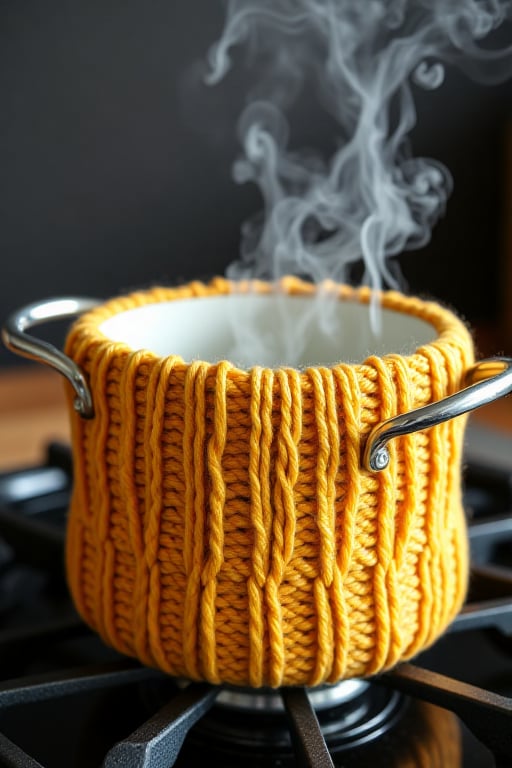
<box><xmin>2</xmin><ymin>296</ymin><xmax>100</xmax><ymax>419</ymax></box>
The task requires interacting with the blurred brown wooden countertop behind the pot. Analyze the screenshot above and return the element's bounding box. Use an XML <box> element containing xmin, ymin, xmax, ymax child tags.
<box><xmin>0</xmin><ymin>366</ymin><xmax>512</xmax><ymax>471</ymax></box>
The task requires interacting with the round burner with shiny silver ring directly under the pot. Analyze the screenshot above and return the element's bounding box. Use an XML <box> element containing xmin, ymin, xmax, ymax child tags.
<box><xmin>183</xmin><ymin>681</ymin><xmax>407</xmax><ymax>766</ymax></box>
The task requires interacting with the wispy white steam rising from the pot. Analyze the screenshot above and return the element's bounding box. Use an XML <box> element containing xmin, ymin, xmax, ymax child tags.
<box><xmin>204</xmin><ymin>0</ymin><xmax>512</xmax><ymax>366</ymax></box>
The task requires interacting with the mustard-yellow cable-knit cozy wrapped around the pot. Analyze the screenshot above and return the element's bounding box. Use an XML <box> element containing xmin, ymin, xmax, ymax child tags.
<box><xmin>66</xmin><ymin>278</ymin><xmax>473</xmax><ymax>686</ymax></box>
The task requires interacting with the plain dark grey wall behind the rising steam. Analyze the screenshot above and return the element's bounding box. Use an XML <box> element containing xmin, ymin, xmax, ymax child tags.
<box><xmin>0</xmin><ymin>0</ymin><xmax>512</xmax><ymax>365</ymax></box>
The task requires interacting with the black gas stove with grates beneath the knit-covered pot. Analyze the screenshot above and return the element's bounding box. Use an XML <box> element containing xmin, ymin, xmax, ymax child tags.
<box><xmin>0</xmin><ymin>433</ymin><xmax>512</xmax><ymax>768</ymax></box>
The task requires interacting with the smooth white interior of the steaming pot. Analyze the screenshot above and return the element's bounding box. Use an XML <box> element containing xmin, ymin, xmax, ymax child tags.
<box><xmin>100</xmin><ymin>294</ymin><xmax>437</xmax><ymax>368</ymax></box>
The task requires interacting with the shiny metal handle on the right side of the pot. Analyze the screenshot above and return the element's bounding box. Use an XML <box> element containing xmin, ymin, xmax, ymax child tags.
<box><xmin>363</xmin><ymin>357</ymin><xmax>512</xmax><ymax>472</ymax></box>
